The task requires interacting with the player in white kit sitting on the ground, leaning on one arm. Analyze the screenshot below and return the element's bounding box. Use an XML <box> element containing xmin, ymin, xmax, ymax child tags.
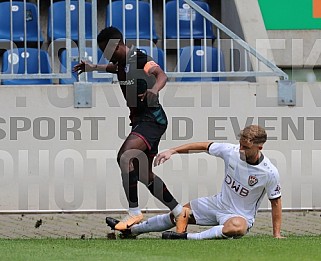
<box><xmin>106</xmin><ymin>125</ymin><xmax>282</xmax><ymax>240</ymax></box>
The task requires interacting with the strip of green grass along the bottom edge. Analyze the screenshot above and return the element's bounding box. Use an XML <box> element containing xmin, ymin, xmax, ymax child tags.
<box><xmin>0</xmin><ymin>236</ymin><xmax>321</xmax><ymax>261</ymax></box>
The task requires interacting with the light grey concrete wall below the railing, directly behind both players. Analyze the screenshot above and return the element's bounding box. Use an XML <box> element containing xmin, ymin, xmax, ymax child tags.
<box><xmin>0</xmin><ymin>82</ymin><xmax>321</xmax><ymax>211</ymax></box>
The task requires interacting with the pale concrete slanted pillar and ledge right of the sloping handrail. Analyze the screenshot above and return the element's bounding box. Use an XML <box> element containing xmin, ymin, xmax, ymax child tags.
<box><xmin>221</xmin><ymin>0</ymin><xmax>321</xmax><ymax>68</ymax></box>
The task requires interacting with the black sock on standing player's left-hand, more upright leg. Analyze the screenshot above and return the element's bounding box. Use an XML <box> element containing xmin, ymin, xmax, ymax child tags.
<box><xmin>121</xmin><ymin>170</ymin><xmax>138</xmax><ymax>208</ymax></box>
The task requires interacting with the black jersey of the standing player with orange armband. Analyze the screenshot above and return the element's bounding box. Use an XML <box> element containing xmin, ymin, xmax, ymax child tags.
<box><xmin>117</xmin><ymin>47</ymin><xmax>167</xmax><ymax>124</ymax></box>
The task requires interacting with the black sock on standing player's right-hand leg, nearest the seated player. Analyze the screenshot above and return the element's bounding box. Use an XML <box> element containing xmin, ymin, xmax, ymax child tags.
<box><xmin>147</xmin><ymin>176</ymin><xmax>178</xmax><ymax>210</ymax></box>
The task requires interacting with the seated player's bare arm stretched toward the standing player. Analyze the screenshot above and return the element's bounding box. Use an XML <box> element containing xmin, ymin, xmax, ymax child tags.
<box><xmin>154</xmin><ymin>142</ymin><xmax>211</xmax><ymax>167</ymax></box>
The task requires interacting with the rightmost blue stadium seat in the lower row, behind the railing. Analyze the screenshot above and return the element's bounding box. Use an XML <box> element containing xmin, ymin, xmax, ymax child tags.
<box><xmin>176</xmin><ymin>46</ymin><xmax>225</xmax><ymax>82</ymax></box>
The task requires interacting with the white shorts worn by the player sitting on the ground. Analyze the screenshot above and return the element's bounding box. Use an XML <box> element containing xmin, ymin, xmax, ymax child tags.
<box><xmin>190</xmin><ymin>193</ymin><xmax>253</xmax><ymax>229</ymax></box>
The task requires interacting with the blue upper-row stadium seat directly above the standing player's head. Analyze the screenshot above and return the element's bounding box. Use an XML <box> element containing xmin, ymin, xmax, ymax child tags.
<box><xmin>106</xmin><ymin>0</ymin><xmax>158</xmax><ymax>41</ymax></box>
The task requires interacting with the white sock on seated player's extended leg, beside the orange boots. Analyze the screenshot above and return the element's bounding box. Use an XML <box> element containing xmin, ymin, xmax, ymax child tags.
<box><xmin>131</xmin><ymin>213</ymin><xmax>175</xmax><ymax>235</ymax></box>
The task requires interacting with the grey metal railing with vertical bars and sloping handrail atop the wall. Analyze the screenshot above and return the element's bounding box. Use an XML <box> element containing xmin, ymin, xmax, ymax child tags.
<box><xmin>0</xmin><ymin>0</ymin><xmax>288</xmax><ymax>81</ymax></box>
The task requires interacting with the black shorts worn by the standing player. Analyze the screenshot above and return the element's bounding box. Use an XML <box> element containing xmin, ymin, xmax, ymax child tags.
<box><xmin>131</xmin><ymin>121</ymin><xmax>167</xmax><ymax>156</ymax></box>
